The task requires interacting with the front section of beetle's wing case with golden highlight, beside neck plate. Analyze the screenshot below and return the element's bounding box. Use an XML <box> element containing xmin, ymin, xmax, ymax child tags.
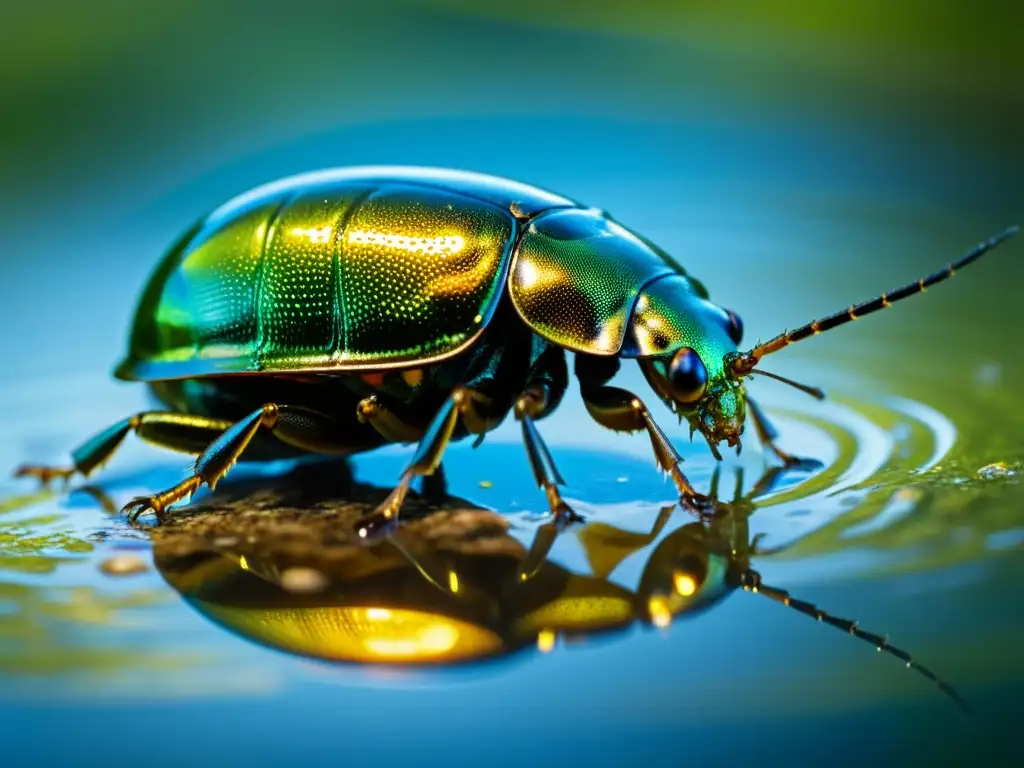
<box><xmin>340</xmin><ymin>187</ymin><xmax>507</xmax><ymax>361</ymax></box>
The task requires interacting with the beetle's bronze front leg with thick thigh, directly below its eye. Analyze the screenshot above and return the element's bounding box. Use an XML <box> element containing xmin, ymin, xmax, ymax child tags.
<box><xmin>583</xmin><ymin>386</ymin><xmax>714</xmax><ymax>508</ymax></box>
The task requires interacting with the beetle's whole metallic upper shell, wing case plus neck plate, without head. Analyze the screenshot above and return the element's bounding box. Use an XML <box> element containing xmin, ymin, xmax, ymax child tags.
<box><xmin>117</xmin><ymin>166</ymin><xmax>689</xmax><ymax>381</ymax></box>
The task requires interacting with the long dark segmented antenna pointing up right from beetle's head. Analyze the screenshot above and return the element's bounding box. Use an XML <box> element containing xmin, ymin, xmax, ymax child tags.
<box><xmin>731</xmin><ymin>224</ymin><xmax>1020</xmax><ymax>376</ymax></box>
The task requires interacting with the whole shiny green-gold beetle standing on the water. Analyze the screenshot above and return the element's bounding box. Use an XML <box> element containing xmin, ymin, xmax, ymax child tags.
<box><xmin>17</xmin><ymin>167</ymin><xmax>1016</xmax><ymax>537</ymax></box>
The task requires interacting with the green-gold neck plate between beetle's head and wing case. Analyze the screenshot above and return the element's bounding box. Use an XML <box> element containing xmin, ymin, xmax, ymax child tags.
<box><xmin>509</xmin><ymin>209</ymin><xmax>683</xmax><ymax>355</ymax></box>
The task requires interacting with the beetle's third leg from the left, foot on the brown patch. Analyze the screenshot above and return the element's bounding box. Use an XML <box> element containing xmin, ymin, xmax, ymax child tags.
<box><xmin>355</xmin><ymin>387</ymin><xmax>476</xmax><ymax>541</ymax></box>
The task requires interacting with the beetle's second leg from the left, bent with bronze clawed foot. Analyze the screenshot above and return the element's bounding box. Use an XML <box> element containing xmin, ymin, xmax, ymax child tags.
<box><xmin>122</xmin><ymin>402</ymin><xmax>336</xmax><ymax>522</ymax></box>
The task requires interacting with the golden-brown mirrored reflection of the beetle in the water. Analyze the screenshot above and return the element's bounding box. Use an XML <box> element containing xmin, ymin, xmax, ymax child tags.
<box><xmin>138</xmin><ymin>460</ymin><xmax>967</xmax><ymax>710</ymax></box>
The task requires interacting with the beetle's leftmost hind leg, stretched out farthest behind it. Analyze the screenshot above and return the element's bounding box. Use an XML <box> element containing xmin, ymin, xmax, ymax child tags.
<box><xmin>14</xmin><ymin>411</ymin><xmax>231</xmax><ymax>485</ymax></box>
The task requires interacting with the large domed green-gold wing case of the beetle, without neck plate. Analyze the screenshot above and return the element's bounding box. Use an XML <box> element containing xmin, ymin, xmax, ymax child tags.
<box><xmin>118</xmin><ymin>169</ymin><xmax>552</xmax><ymax>380</ymax></box>
